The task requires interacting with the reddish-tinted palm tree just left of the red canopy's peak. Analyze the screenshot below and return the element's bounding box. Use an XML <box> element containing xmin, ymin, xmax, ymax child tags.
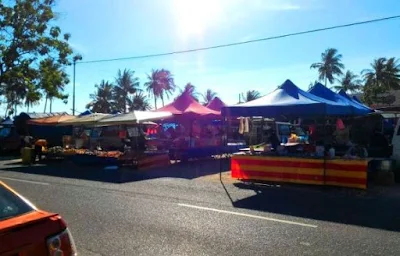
<box><xmin>144</xmin><ymin>69</ymin><xmax>175</xmax><ymax>109</ymax></box>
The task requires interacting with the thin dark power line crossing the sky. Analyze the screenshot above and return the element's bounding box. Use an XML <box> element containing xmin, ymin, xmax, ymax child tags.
<box><xmin>77</xmin><ymin>15</ymin><xmax>400</xmax><ymax>64</ymax></box>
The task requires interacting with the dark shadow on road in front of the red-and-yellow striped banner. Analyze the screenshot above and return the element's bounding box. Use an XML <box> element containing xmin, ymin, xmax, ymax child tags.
<box><xmin>233</xmin><ymin>183</ymin><xmax>400</xmax><ymax>232</ymax></box>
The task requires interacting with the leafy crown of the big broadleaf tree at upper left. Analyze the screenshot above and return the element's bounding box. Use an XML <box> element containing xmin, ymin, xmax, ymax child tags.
<box><xmin>0</xmin><ymin>0</ymin><xmax>72</xmax><ymax>113</ymax></box>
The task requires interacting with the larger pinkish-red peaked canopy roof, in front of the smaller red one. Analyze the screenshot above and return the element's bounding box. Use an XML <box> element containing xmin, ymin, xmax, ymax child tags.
<box><xmin>156</xmin><ymin>93</ymin><xmax>221</xmax><ymax>118</ymax></box>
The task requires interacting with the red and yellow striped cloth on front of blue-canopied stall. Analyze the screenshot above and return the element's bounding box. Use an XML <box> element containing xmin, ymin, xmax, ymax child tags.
<box><xmin>231</xmin><ymin>155</ymin><xmax>368</xmax><ymax>189</ymax></box>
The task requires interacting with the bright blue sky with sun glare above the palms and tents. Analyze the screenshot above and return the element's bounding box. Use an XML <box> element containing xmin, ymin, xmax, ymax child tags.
<box><xmin>22</xmin><ymin>0</ymin><xmax>400</xmax><ymax>112</ymax></box>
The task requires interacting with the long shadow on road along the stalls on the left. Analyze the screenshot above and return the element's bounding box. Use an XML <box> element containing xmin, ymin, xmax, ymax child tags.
<box><xmin>0</xmin><ymin>159</ymin><xmax>229</xmax><ymax>183</ymax></box>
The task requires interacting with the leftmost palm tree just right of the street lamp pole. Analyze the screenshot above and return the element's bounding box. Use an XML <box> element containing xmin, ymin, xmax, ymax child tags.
<box><xmin>86</xmin><ymin>80</ymin><xmax>115</xmax><ymax>113</ymax></box>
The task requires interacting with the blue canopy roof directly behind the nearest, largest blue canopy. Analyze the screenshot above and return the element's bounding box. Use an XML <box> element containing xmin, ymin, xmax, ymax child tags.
<box><xmin>308</xmin><ymin>83</ymin><xmax>371</xmax><ymax>116</ymax></box>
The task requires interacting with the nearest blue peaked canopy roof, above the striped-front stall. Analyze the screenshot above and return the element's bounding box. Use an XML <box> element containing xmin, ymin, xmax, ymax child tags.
<box><xmin>222</xmin><ymin>80</ymin><xmax>351</xmax><ymax>117</ymax></box>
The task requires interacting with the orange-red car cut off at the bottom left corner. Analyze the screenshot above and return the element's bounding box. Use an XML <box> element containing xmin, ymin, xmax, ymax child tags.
<box><xmin>0</xmin><ymin>181</ymin><xmax>77</xmax><ymax>256</ymax></box>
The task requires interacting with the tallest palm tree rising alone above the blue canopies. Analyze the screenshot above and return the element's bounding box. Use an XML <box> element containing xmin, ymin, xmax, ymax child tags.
<box><xmin>310</xmin><ymin>48</ymin><xmax>344</xmax><ymax>86</ymax></box>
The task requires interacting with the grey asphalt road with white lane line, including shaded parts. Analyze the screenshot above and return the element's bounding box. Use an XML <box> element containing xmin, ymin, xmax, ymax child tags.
<box><xmin>0</xmin><ymin>159</ymin><xmax>400</xmax><ymax>255</ymax></box>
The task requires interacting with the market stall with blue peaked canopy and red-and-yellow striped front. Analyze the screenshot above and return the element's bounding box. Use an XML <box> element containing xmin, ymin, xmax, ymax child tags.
<box><xmin>222</xmin><ymin>80</ymin><xmax>368</xmax><ymax>189</ymax></box>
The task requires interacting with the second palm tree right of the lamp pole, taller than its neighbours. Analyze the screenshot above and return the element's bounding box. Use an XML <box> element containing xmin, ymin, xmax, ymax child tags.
<box><xmin>113</xmin><ymin>69</ymin><xmax>139</xmax><ymax>113</ymax></box>
